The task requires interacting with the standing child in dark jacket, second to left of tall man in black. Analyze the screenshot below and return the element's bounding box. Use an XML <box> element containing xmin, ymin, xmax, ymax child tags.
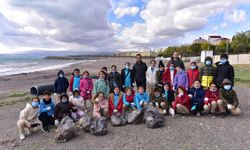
<box><xmin>108</xmin><ymin>65</ymin><xmax>121</xmax><ymax>93</ymax></box>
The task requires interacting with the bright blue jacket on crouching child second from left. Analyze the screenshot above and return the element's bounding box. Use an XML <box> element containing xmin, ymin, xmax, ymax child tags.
<box><xmin>39</xmin><ymin>99</ymin><xmax>55</xmax><ymax>116</ymax></box>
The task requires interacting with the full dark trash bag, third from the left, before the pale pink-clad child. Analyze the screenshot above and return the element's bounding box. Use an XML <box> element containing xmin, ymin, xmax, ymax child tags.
<box><xmin>90</xmin><ymin>117</ymin><xmax>108</xmax><ymax>135</ymax></box>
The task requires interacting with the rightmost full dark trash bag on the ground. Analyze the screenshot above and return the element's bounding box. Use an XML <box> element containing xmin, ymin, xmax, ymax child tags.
<box><xmin>144</xmin><ymin>106</ymin><xmax>166</xmax><ymax>128</ymax></box>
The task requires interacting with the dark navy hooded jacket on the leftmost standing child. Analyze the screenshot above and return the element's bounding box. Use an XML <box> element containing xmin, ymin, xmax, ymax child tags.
<box><xmin>54</xmin><ymin>70</ymin><xmax>69</xmax><ymax>94</ymax></box>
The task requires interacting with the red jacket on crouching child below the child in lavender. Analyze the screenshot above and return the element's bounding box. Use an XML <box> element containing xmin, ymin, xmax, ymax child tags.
<box><xmin>172</xmin><ymin>87</ymin><xmax>191</xmax><ymax>111</ymax></box>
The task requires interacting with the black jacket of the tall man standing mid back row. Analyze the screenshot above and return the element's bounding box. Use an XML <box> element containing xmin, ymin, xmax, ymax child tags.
<box><xmin>132</xmin><ymin>62</ymin><xmax>148</xmax><ymax>82</ymax></box>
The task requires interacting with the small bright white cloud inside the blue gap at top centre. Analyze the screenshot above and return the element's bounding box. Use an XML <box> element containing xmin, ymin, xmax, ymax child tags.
<box><xmin>114</xmin><ymin>7</ymin><xmax>140</xmax><ymax>19</ymax></box>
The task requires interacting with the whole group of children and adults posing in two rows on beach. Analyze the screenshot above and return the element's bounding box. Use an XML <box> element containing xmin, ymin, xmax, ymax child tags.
<box><xmin>17</xmin><ymin>52</ymin><xmax>240</xmax><ymax>140</ymax></box>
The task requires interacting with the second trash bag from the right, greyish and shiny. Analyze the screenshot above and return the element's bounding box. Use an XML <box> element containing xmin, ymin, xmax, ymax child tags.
<box><xmin>126</xmin><ymin>110</ymin><xmax>143</xmax><ymax>124</ymax></box>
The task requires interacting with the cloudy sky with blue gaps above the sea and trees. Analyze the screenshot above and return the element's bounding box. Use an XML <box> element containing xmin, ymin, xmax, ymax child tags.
<box><xmin>0</xmin><ymin>0</ymin><xmax>250</xmax><ymax>54</ymax></box>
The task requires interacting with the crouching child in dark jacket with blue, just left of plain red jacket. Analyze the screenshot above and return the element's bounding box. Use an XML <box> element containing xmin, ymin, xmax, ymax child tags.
<box><xmin>163</xmin><ymin>82</ymin><xmax>174</xmax><ymax>112</ymax></box>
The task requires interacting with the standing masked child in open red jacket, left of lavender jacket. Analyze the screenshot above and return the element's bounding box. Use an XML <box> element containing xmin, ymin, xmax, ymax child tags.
<box><xmin>162</xmin><ymin>63</ymin><xmax>177</xmax><ymax>88</ymax></box>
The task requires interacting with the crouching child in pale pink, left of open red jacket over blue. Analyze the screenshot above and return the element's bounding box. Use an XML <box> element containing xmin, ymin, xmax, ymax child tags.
<box><xmin>93</xmin><ymin>92</ymin><xmax>109</xmax><ymax>118</ymax></box>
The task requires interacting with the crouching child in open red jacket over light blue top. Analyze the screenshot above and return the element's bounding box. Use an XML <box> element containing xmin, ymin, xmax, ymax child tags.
<box><xmin>109</xmin><ymin>86</ymin><xmax>123</xmax><ymax>116</ymax></box>
